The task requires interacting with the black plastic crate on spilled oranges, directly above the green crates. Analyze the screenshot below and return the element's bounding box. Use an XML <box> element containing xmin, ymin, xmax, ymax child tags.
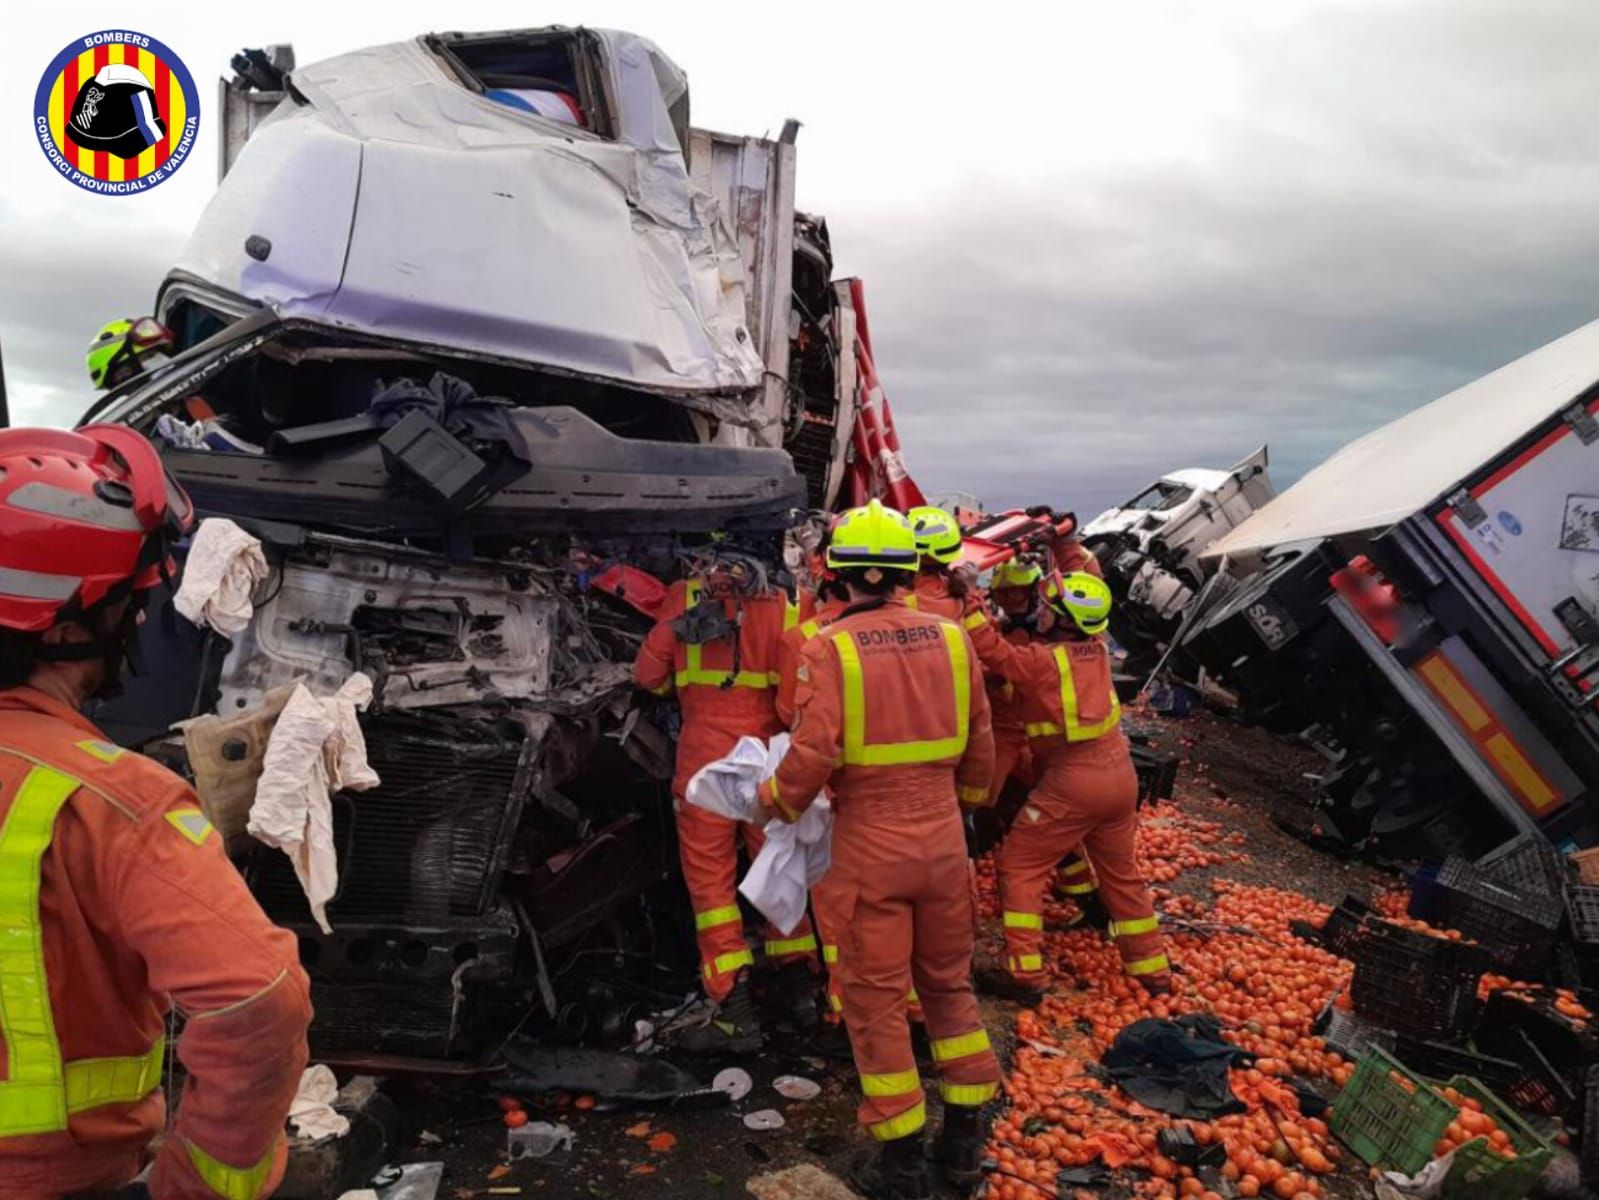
<box><xmin>1350</xmin><ymin>918</ymin><xmax>1484</xmax><ymax>1042</ymax></box>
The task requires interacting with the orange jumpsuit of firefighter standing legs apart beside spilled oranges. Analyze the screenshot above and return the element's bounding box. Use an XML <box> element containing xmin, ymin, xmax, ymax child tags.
<box><xmin>967</xmin><ymin>608</ymin><xmax>1170</xmax><ymax>984</ymax></box>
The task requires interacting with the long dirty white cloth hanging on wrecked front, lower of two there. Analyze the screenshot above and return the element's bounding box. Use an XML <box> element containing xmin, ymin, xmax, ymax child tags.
<box><xmin>246</xmin><ymin>672</ymin><xmax>381</xmax><ymax>933</ymax></box>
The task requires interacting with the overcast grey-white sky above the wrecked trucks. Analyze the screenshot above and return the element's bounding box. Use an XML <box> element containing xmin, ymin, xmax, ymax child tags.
<box><xmin>0</xmin><ymin>0</ymin><xmax>1599</xmax><ymax>514</ymax></box>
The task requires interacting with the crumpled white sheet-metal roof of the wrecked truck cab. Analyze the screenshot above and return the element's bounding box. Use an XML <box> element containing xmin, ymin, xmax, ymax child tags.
<box><xmin>177</xmin><ymin>30</ymin><xmax>763</xmax><ymax>405</ymax></box>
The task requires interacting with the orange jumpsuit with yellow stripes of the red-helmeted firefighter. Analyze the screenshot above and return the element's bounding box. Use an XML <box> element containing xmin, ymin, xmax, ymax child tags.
<box><xmin>0</xmin><ymin>688</ymin><xmax>310</xmax><ymax>1200</ymax></box>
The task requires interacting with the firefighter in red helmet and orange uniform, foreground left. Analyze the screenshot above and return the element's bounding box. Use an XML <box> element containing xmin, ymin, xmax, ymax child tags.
<box><xmin>0</xmin><ymin>426</ymin><xmax>310</xmax><ymax>1200</ymax></box>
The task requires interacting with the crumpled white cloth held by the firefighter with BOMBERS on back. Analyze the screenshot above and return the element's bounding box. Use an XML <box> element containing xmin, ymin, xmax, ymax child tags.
<box><xmin>684</xmin><ymin>733</ymin><xmax>833</xmax><ymax>931</ymax></box>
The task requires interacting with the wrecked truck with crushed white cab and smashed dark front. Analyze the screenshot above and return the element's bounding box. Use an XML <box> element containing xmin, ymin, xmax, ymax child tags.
<box><xmin>85</xmin><ymin>29</ymin><xmax>914</xmax><ymax>1058</ymax></box>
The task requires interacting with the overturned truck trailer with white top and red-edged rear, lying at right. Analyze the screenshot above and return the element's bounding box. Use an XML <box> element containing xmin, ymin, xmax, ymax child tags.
<box><xmin>1185</xmin><ymin>312</ymin><xmax>1599</xmax><ymax>853</ymax></box>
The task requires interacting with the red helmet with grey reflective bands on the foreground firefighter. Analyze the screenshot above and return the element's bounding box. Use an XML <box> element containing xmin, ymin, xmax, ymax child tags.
<box><xmin>0</xmin><ymin>426</ymin><xmax>193</xmax><ymax>634</ymax></box>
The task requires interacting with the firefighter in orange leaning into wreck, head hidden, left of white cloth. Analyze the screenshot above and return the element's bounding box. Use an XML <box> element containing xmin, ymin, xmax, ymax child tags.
<box><xmin>633</xmin><ymin>571</ymin><xmax>819</xmax><ymax>1053</ymax></box>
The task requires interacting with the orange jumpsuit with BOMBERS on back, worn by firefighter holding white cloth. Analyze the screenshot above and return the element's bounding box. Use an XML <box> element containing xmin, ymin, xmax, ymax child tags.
<box><xmin>761</xmin><ymin>597</ymin><xmax>999</xmax><ymax>1141</ymax></box>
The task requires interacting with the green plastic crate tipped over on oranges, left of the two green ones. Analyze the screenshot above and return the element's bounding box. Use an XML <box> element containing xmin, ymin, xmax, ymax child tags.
<box><xmin>1330</xmin><ymin>1048</ymin><xmax>1458</xmax><ymax>1174</ymax></box>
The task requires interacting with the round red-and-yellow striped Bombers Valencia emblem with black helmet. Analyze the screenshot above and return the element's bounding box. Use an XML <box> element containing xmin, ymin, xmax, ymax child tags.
<box><xmin>34</xmin><ymin>29</ymin><xmax>200</xmax><ymax>195</ymax></box>
